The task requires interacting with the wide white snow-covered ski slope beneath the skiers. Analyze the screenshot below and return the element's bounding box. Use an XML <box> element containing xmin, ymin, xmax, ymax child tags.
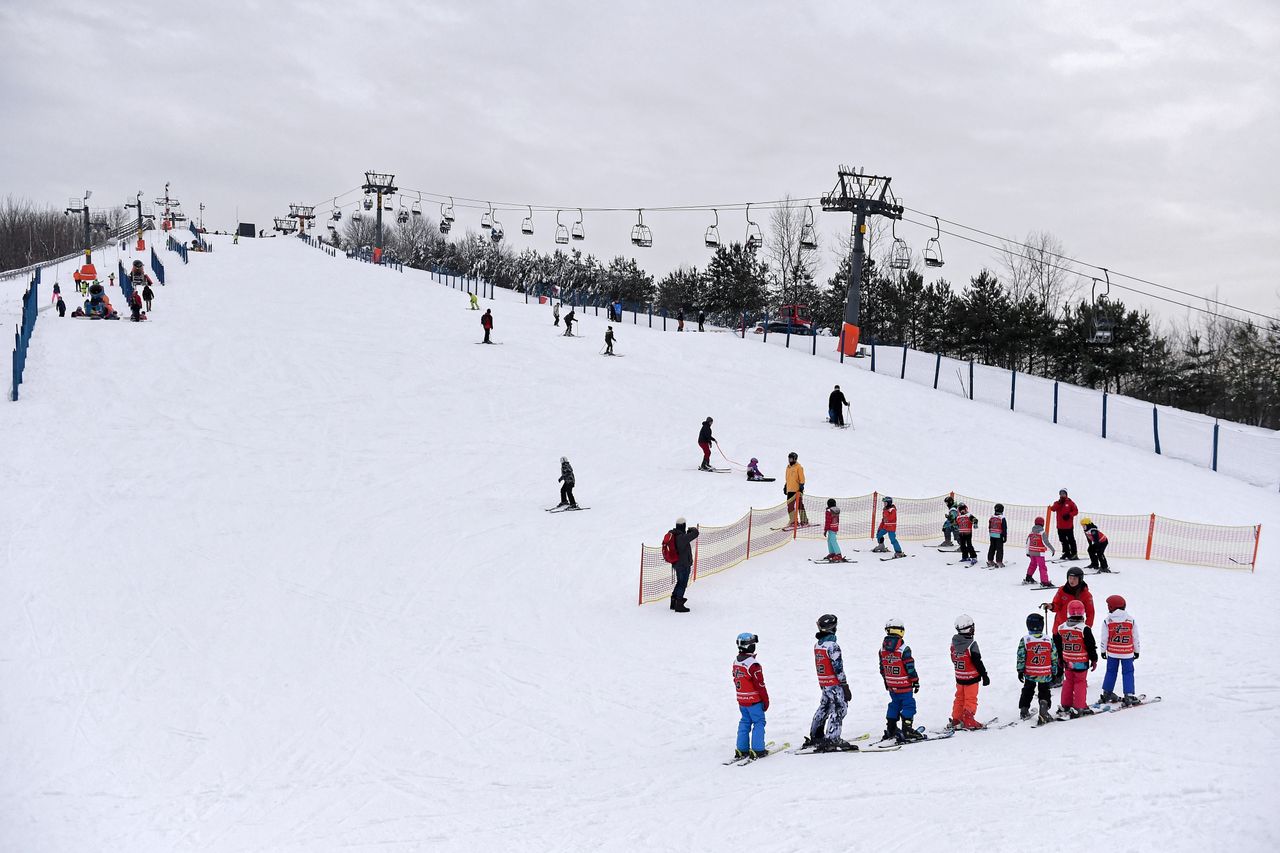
<box><xmin>0</xmin><ymin>229</ymin><xmax>1280</xmax><ymax>852</ymax></box>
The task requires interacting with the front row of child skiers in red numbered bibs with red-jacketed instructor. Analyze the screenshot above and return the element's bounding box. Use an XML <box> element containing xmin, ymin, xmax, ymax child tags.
<box><xmin>732</xmin><ymin>591</ymin><xmax>1142</xmax><ymax>760</ymax></box>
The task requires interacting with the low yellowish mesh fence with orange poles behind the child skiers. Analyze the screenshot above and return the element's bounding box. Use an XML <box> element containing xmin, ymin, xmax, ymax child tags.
<box><xmin>636</xmin><ymin>492</ymin><xmax>1262</xmax><ymax>605</ymax></box>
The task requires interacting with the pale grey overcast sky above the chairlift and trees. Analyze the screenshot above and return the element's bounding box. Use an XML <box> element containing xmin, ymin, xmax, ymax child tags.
<box><xmin>0</xmin><ymin>0</ymin><xmax>1280</xmax><ymax>321</ymax></box>
